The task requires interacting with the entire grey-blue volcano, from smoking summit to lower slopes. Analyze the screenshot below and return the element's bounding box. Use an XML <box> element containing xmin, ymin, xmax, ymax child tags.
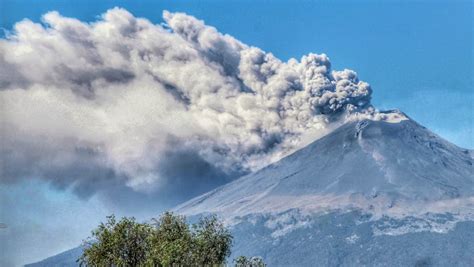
<box><xmin>26</xmin><ymin>115</ymin><xmax>474</xmax><ymax>266</ymax></box>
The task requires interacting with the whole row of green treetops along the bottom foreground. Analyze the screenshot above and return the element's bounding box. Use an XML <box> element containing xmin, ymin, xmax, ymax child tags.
<box><xmin>78</xmin><ymin>212</ymin><xmax>265</xmax><ymax>267</ymax></box>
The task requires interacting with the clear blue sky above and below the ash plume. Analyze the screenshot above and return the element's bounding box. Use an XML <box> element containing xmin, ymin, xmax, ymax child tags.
<box><xmin>0</xmin><ymin>0</ymin><xmax>474</xmax><ymax>264</ymax></box>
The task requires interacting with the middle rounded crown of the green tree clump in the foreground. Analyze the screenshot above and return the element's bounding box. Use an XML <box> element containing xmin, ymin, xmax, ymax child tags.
<box><xmin>148</xmin><ymin>212</ymin><xmax>193</xmax><ymax>266</ymax></box>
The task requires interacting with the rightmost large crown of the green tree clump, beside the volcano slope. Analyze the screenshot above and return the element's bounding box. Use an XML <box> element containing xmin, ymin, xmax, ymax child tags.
<box><xmin>193</xmin><ymin>215</ymin><xmax>232</xmax><ymax>266</ymax></box>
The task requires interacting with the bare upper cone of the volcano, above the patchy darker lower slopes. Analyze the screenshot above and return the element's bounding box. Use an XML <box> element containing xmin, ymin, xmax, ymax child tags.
<box><xmin>177</xmin><ymin>118</ymin><xmax>474</xmax><ymax>221</ymax></box>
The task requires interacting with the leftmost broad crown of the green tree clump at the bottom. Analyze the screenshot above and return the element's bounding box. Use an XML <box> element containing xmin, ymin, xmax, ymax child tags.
<box><xmin>78</xmin><ymin>215</ymin><xmax>153</xmax><ymax>266</ymax></box>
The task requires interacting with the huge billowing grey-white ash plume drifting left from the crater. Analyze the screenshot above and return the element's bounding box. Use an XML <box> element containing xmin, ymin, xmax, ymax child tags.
<box><xmin>0</xmin><ymin>8</ymin><xmax>384</xmax><ymax>205</ymax></box>
